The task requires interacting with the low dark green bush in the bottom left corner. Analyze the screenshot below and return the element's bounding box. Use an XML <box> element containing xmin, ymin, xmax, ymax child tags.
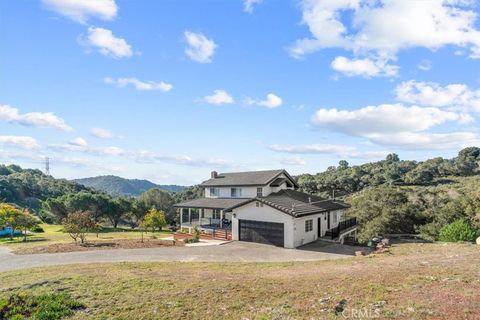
<box><xmin>0</xmin><ymin>293</ymin><xmax>85</xmax><ymax>320</ymax></box>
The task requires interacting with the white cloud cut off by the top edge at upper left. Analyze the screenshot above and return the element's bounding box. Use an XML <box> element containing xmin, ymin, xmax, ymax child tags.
<box><xmin>42</xmin><ymin>0</ymin><xmax>118</xmax><ymax>24</ymax></box>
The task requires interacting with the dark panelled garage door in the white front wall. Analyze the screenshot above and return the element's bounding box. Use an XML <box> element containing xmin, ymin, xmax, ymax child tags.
<box><xmin>238</xmin><ymin>219</ymin><xmax>284</xmax><ymax>247</ymax></box>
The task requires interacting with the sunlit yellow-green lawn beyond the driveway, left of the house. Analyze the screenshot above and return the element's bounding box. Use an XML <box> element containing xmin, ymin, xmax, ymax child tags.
<box><xmin>0</xmin><ymin>224</ymin><xmax>171</xmax><ymax>251</ymax></box>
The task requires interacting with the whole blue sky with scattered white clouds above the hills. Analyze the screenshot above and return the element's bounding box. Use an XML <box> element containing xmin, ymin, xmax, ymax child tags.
<box><xmin>0</xmin><ymin>0</ymin><xmax>480</xmax><ymax>184</ymax></box>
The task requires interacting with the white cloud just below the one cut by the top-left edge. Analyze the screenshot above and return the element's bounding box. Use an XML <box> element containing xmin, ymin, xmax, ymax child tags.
<box><xmin>80</xmin><ymin>27</ymin><xmax>133</xmax><ymax>59</ymax></box>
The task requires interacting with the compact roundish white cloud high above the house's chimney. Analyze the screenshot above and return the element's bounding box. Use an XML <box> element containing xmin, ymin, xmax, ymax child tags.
<box><xmin>184</xmin><ymin>31</ymin><xmax>218</xmax><ymax>63</ymax></box>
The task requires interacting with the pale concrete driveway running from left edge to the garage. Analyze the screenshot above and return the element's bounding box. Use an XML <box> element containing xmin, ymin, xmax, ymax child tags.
<box><xmin>0</xmin><ymin>241</ymin><xmax>364</xmax><ymax>272</ymax></box>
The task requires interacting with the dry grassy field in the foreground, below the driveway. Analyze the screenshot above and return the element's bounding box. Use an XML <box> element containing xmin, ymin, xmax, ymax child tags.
<box><xmin>0</xmin><ymin>243</ymin><xmax>480</xmax><ymax>319</ymax></box>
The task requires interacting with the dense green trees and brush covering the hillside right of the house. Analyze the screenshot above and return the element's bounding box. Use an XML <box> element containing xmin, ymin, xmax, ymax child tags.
<box><xmin>298</xmin><ymin>147</ymin><xmax>480</xmax><ymax>242</ymax></box>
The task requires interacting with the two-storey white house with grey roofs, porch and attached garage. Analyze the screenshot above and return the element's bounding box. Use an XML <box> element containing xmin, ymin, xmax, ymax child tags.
<box><xmin>175</xmin><ymin>170</ymin><xmax>357</xmax><ymax>248</ymax></box>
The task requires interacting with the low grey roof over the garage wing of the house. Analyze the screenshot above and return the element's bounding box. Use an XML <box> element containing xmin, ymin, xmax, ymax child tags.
<box><xmin>229</xmin><ymin>190</ymin><xmax>350</xmax><ymax>217</ymax></box>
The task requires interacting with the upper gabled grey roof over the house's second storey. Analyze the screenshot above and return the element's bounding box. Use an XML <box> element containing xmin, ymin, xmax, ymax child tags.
<box><xmin>200</xmin><ymin>169</ymin><xmax>298</xmax><ymax>188</ymax></box>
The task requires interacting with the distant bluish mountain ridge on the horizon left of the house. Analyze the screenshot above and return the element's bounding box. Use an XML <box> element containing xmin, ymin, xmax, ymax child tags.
<box><xmin>74</xmin><ymin>176</ymin><xmax>186</xmax><ymax>196</ymax></box>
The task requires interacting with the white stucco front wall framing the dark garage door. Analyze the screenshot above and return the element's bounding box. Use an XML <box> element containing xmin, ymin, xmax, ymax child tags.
<box><xmin>232</xmin><ymin>201</ymin><xmax>295</xmax><ymax>248</ymax></box>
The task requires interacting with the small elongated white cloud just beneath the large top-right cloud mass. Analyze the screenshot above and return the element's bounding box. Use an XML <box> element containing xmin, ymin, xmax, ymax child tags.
<box><xmin>331</xmin><ymin>56</ymin><xmax>399</xmax><ymax>78</ymax></box>
